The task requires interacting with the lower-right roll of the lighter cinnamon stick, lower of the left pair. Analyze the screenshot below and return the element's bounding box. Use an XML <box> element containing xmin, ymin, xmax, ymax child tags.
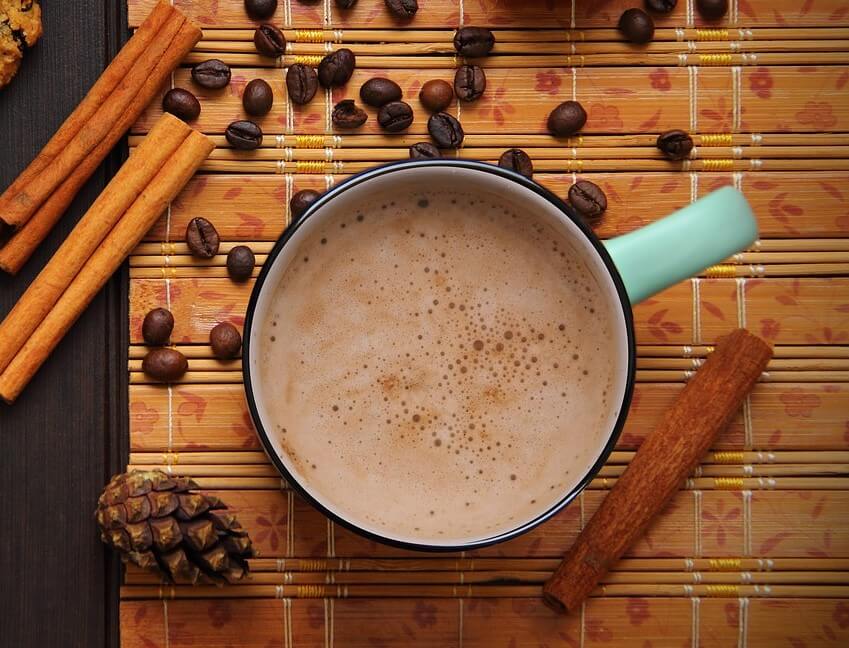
<box><xmin>0</xmin><ymin>131</ymin><xmax>215</xmax><ymax>403</ymax></box>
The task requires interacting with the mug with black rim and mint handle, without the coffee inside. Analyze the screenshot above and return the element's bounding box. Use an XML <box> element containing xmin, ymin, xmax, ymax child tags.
<box><xmin>242</xmin><ymin>159</ymin><xmax>757</xmax><ymax>551</ymax></box>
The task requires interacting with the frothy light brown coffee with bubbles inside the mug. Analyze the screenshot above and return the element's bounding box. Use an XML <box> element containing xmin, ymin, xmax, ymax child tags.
<box><xmin>259</xmin><ymin>185</ymin><xmax>621</xmax><ymax>543</ymax></box>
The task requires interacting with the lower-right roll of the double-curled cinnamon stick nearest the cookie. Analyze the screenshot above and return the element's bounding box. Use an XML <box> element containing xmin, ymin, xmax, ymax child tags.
<box><xmin>0</xmin><ymin>22</ymin><xmax>200</xmax><ymax>274</ymax></box>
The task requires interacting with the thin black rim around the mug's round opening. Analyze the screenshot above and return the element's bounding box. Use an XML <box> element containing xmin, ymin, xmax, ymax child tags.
<box><xmin>242</xmin><ymin>158</ymin><xmax>636</xmax><ymax>552</ymax></box>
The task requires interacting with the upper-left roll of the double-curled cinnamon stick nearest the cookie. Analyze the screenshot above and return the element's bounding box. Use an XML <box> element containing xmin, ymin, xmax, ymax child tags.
<box><xmin>0</xmin><ymin>0</ymin><xmax>175</xmax><ymax>201</ymax></box>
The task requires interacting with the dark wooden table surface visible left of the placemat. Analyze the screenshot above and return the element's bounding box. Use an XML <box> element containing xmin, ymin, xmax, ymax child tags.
<box><xmin>0</xmin><ymin>0</ymin><xmax>127</xmax><ymax>648</ymax></box>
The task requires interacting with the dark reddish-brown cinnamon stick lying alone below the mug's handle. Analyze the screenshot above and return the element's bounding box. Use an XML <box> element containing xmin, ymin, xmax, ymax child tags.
<box><xmin>543</xmin><ymin>329</ymin><xmax>772</xmax><ymax>612</ymax></box>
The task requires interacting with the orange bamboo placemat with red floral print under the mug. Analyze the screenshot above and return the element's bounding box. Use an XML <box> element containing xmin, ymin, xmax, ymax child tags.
<box><xmin>121</xmin><ymin>0</ymin><xmax>849</xmax><ymax>648</ymax></box>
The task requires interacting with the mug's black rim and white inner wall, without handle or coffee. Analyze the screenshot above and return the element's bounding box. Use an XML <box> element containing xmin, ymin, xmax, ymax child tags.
<box><xmin>244</xmin><ymin>162</ymin><xmax>633</xmax><ymax>550</ymax></box>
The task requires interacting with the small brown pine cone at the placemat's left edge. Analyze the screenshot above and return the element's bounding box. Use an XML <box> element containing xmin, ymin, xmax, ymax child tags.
<box><xmin>95</xmin><ymin>470</ymin><xmax>254</xmax><ymax>585</ymax></box>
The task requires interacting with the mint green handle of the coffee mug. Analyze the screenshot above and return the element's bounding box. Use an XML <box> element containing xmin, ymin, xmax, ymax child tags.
<box><xmin>606</xmin><ymin>187</ymin><xmax>758</xmax><ymax>304</ymax></box>
